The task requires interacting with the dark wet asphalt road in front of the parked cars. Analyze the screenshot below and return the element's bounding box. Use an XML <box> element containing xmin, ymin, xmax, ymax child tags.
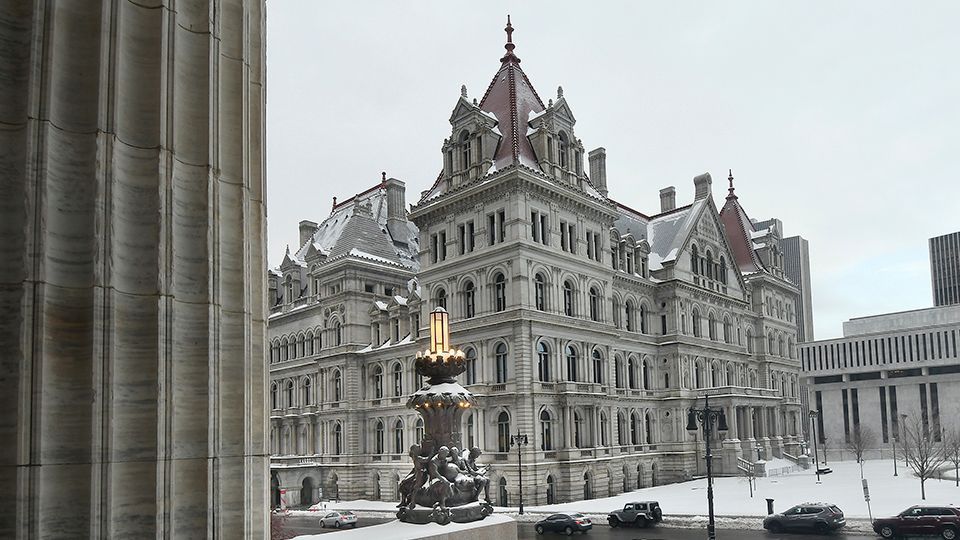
<box><xmin>520</xmin><ymin>523</ymin><xmax>877</xmax><ymax>540</ymax></box>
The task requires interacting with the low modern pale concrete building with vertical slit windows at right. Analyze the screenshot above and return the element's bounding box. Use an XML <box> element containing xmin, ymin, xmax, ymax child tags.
<box><xmin>800</xmin><ymin>306</ymin><xmax>960</xmax><ymax>459</ymax></box>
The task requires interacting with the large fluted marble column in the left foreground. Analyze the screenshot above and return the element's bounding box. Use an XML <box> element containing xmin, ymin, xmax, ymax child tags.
<box><xmin>0</xmin><ymin>0</ymin><xmax>269</xmax><ymax>538</ymax></box>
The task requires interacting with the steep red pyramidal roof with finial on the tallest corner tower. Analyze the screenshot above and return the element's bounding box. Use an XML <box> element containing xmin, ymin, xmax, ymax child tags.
<box><xmin>480</xmin><ymin>16</ymin><xmax>546</xmax><ymax>171</ymax></box>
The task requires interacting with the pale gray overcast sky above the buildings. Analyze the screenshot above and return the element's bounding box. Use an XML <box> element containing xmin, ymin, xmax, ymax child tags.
<box><xmin>267</xmin><ymin>0</ymin><xmax>960</xmax><ymax>339</ymax></box>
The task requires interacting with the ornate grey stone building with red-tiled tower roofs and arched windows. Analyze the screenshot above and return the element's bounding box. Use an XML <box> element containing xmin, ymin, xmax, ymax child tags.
<box><xmin>268</xmin><ymin>25</ymin><xmax>804</xmax><ymax>505</ymax></box>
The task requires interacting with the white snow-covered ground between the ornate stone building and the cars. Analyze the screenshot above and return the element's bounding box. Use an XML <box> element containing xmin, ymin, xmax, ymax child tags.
<box><xmin>288</xmin><ymin>459</ymin><xmax>960</xmax><ymax>528</ymax></box>
